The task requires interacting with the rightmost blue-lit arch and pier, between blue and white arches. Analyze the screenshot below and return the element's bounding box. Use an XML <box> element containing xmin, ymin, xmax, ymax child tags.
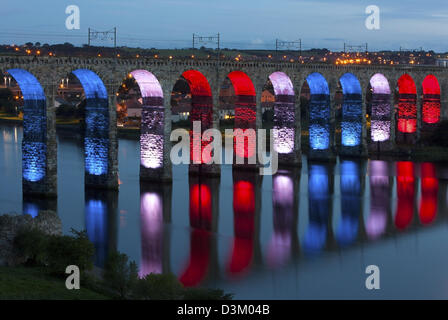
<box><xmin>339</xmin><ymin>73</ymin><xmax>362</xmax><ymax>147</ymax></box>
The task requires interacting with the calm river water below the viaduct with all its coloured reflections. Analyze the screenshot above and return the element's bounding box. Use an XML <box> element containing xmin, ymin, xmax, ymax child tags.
<box><xmin>0</xmin><ymin>125</ymin><xmax>448</xmax><ymax>299</ymax></box>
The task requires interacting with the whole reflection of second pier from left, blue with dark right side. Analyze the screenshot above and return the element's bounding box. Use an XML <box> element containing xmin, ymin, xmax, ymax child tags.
<box><xmin>85</xmin><ymin>188</ymin><xmax>118</xmax><ymax>267</ymax></box>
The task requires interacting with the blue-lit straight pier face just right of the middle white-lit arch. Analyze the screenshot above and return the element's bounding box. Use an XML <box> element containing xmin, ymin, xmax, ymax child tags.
<box><xmin>309</xmin><ymin>94</ymin><xmax>330</xmax><ymax>150</ymax></box>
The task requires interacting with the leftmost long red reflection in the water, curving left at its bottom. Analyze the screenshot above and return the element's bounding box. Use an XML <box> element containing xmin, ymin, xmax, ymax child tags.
<box><xmin>179</xmin><ymin>184</ymin><xmax>213</xmax><ymax>287</ymax></box>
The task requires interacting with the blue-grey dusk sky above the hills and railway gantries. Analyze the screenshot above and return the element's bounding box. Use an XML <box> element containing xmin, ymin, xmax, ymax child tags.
<box><xmin>0</xmin><ymin>0</ymin><xmax>448</xmax><ymax>52</ymax></box>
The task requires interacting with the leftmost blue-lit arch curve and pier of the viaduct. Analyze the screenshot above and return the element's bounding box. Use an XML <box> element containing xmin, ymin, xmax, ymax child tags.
<box><xmin>7</xmin><ymin>69</ymin><xmax>47</xmax><ymax>182</ymax></box>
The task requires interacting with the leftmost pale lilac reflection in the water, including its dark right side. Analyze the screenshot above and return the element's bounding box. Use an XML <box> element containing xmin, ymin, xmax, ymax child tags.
<box><xmin>139</xmin><ymin>183</ymin><xmax>172</xmax><ymax>278</ymax></box>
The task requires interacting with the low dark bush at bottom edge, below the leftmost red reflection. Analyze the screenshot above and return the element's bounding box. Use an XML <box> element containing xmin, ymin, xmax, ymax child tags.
<box><xmin>134</xmin><ymin>273</ymin><xmax>184</xmax><ymax>300</ymax></box>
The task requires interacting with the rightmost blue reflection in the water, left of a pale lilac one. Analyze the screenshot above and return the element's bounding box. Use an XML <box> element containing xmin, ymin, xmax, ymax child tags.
<box><xmin>336</xmin><ymin>161</ymin><xmax>361</xmax><ymax>246</ymax></box>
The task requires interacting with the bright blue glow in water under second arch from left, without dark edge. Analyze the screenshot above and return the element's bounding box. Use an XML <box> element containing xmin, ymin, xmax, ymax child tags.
<box><xmin>85</xmin><ymin>199</ymin><xmax>108</xmax><ymax>266</ymax></box>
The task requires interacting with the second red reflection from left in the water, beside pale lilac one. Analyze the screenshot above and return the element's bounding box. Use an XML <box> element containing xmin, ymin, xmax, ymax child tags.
<box><xmin>227</xmin><ymin>181</ymin><xmax>255</xmax><ymax>274</ymax></box>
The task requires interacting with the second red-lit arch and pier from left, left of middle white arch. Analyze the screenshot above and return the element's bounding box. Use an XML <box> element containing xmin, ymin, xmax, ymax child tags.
<box><xmin>228</xmin><ymin>71</ymin><xmax>256</xmax><ymax>158</ymax></box>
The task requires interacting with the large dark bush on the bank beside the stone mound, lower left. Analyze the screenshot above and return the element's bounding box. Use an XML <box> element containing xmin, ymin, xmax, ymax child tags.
<box><xmin>48</xmin><ymin>229</ymin><xmax>95</xmax><ymax>275</ymax></box>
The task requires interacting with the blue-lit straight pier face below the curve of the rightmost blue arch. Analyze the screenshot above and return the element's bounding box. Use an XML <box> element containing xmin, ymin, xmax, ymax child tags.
<box><xmin>341</xmin><ymin>95</ymin><xmax>362</xmax><ymax>147</ymax></box>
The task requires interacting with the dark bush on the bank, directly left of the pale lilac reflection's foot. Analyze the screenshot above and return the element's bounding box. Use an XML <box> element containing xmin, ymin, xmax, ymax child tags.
<box><xmin>104</xmin><ymin>251</ymin><xmax>138</xmax><ymax>299</ymax></box>
